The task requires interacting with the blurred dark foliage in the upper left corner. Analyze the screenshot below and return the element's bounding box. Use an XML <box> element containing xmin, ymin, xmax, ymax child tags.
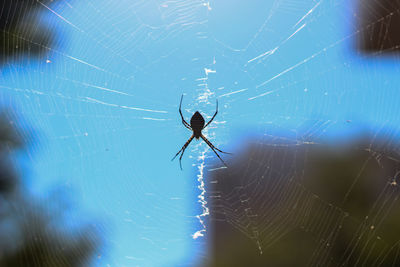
<box><xmin>0</xmin><ymin>0</ymin><xmax>55</xmax><ymax>64</ymax></box>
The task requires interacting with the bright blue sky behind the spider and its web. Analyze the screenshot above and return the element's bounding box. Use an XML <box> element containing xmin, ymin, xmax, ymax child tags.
<box><xmin>0</xmin><ymin>0</ymin><xmax>400</xmax><ymax>266</ymax></box>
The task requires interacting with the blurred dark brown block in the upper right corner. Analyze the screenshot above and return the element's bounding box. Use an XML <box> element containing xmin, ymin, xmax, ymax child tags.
<box><xmin>358</xmin><ymin>0</ymin><xmax>400</xmax><ymax>54</ymax></box>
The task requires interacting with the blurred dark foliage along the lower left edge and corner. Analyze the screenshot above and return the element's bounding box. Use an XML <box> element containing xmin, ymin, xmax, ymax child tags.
<box><xmin>0</xmin><ymin>114</ymin><xmax>100</xmax><ymax>267</ymax></box>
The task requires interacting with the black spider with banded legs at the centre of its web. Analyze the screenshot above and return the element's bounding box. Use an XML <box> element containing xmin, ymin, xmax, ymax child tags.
<box><xmin>171</xmin><ymin>95</ymin><xmax>232</xmax><ymax>170</ymax></box>
